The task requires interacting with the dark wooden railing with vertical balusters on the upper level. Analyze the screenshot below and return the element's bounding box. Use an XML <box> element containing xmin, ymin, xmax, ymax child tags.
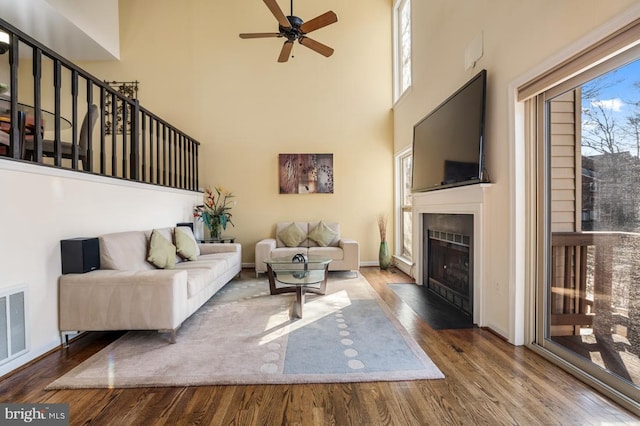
<box><xmin>0</xmin><ymin>19</ymin><xmax>200</xmax><ymax>190</ymax></box>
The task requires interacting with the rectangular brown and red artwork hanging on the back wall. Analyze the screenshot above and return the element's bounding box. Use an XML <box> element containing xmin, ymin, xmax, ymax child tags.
<box><xmin>278</xmin><ymin>154</ymin><xmax>333</xmax><ymax>194</ymax></box>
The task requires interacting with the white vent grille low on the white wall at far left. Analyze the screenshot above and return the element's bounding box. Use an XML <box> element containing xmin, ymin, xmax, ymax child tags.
<box><xmin>0</xmin><ymin>289</ymin><xmax>27</xmax><ymax>364</ymax></box>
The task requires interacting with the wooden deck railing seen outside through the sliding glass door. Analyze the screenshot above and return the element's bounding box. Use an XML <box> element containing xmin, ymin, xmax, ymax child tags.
<box><xmin>549</xmin><ymin>232</ymin><xmax>640</xmax><ymax>355</ymax></box>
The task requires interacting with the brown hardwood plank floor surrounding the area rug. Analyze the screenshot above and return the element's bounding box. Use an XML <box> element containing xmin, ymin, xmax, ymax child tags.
<box><xmin>0</xmin><ymin>268</ymin><xmax>640</xmax><ymax>425</ymax></box>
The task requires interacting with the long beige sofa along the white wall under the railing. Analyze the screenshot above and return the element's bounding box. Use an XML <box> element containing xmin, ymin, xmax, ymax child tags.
<box><xmin>59</xmin><ymin>227</ymin><xmax>242</xmax><ymax>342</ymax></box>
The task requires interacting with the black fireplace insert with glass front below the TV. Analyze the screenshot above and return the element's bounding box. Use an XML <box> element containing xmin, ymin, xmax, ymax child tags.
<box><xmin>425</xmin><ymin>229</ymin><xmax>473</xmax><ymax>316</ymax></box>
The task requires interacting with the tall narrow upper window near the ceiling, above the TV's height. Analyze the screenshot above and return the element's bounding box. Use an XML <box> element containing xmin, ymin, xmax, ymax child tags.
<box><xmin>394</xmin><ymin>0</ymin><xmax>411</xmax><ymax>101</ymax></box>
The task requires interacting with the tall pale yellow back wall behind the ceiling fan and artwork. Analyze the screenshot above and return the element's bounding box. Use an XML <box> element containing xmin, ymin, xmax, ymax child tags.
<box><xmin>75</xmin><ymin>0</ymin><xmax>393</xmax><ymax>263</ymax></box>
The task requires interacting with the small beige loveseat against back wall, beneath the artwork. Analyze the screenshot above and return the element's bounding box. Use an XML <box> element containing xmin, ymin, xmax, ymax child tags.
<box><xmin>255</xmin><ymin>221</ymin><xmax>360</xmax><ymax>275</ymax></box>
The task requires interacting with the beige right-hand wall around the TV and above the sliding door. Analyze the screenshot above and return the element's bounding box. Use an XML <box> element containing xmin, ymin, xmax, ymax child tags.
<box><xmin>394</xmin><ymin>0</ymin><xmax>636</xmax><ymax>340</ymax></box>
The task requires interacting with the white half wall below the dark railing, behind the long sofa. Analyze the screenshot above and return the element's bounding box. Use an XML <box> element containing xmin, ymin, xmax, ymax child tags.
<box><xmin>0</xmin><ymin>158</ymin><xmax>201</xmax><ymax>375</ymax></box>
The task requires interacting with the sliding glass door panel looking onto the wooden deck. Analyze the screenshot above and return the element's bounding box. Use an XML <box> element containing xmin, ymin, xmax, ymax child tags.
<box><xmin>534</xmin><ymin>49</ymin><xmax>640</xmax><ymax>401</ymax></box>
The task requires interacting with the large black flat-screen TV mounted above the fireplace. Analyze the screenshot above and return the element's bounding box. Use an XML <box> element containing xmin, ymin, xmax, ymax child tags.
<box><xmin>411</xmin><ymin>70</ymin><xmax>487</xmax><ymax>192</ymax></box>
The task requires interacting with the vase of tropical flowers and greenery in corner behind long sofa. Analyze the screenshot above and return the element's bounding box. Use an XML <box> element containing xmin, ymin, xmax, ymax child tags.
<box><xmin>193</xmin><ymin>186</ymin><xmax>235</xmax><ymax>240</ymax></box>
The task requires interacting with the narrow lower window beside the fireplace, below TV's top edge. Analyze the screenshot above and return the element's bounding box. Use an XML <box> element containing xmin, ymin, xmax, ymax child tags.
<box><xmin>395</xmin><ymin>149</ymin><xmax>413</xmax><ymax>264</ymax></box>
